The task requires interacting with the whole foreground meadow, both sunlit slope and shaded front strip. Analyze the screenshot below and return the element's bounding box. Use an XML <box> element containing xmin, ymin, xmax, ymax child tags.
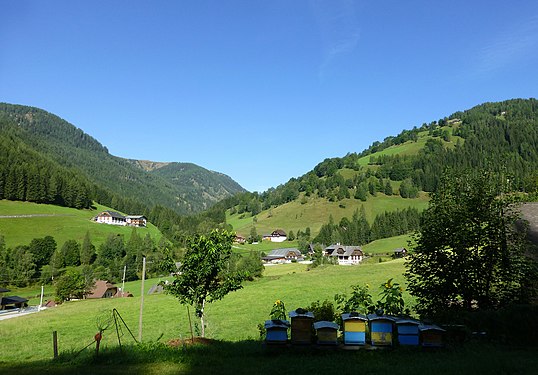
<box><xmin>0</xmin><ymin>260</ymin><xmax>538</xmax><ymax>375</ymax></box>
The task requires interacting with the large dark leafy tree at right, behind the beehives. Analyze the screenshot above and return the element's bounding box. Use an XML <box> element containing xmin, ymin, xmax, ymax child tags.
<box><xmin>406</xmin><ymin>172</ymin><xmax>529</xmax><ymax>314</ymax></box>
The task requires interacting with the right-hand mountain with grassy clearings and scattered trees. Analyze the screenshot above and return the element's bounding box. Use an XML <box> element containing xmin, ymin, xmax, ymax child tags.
<box><xmin>219</xmin><ymin>98</ymin><xmax>538</xmax><ymax>241</ymax></box>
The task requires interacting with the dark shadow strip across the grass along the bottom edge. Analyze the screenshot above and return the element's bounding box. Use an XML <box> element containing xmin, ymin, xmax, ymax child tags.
<box><xmin>0</xmin><ymin>341</ymin><xmax>538</xmax><ymax>375</ymax></box>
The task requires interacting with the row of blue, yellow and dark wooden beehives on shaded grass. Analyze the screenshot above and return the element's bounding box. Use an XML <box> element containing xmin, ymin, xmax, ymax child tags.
<box><xmin>265</xmin><ymin>309</ymin><xmax>445</xmax><ymax>347</ymax></box>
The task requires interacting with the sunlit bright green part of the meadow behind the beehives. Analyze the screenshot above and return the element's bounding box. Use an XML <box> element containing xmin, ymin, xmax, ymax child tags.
<box><xmin>0</xmin><ymin>260</ymin><xmax>411</xmax><ymax>362</ymax></box>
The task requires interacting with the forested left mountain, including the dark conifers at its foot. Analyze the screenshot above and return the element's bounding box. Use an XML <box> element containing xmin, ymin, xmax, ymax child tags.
<box><xmin>0</xmin><ymin>103</ymin><xmax>245</xmax><ymax>214</ymax></box>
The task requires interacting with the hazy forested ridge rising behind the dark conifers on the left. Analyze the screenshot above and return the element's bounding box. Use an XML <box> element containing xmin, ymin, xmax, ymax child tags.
<box><xmin>0</xmin><ymin>103</ymin><xmax>246</xmax><ymax>214</ymax></box>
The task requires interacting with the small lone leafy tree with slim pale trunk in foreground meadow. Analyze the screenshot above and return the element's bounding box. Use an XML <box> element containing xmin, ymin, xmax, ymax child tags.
<box><xmin>165</xmin><ymin>229</ymin><xmax>244</xmax><ymax>337</ymax></box>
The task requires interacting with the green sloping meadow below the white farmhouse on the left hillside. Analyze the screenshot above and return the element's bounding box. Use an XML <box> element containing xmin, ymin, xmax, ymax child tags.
<box><xmin>0</xmin><ymin>200</ymin><xmax>162</xmax><ymax>247</ymax></box>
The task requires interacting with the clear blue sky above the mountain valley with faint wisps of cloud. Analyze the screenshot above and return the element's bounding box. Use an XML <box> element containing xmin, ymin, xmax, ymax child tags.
<box><xmin>0</xmin><ymin>0</ymin><xmax>538</xmax><ymax>191</ymax></box>
